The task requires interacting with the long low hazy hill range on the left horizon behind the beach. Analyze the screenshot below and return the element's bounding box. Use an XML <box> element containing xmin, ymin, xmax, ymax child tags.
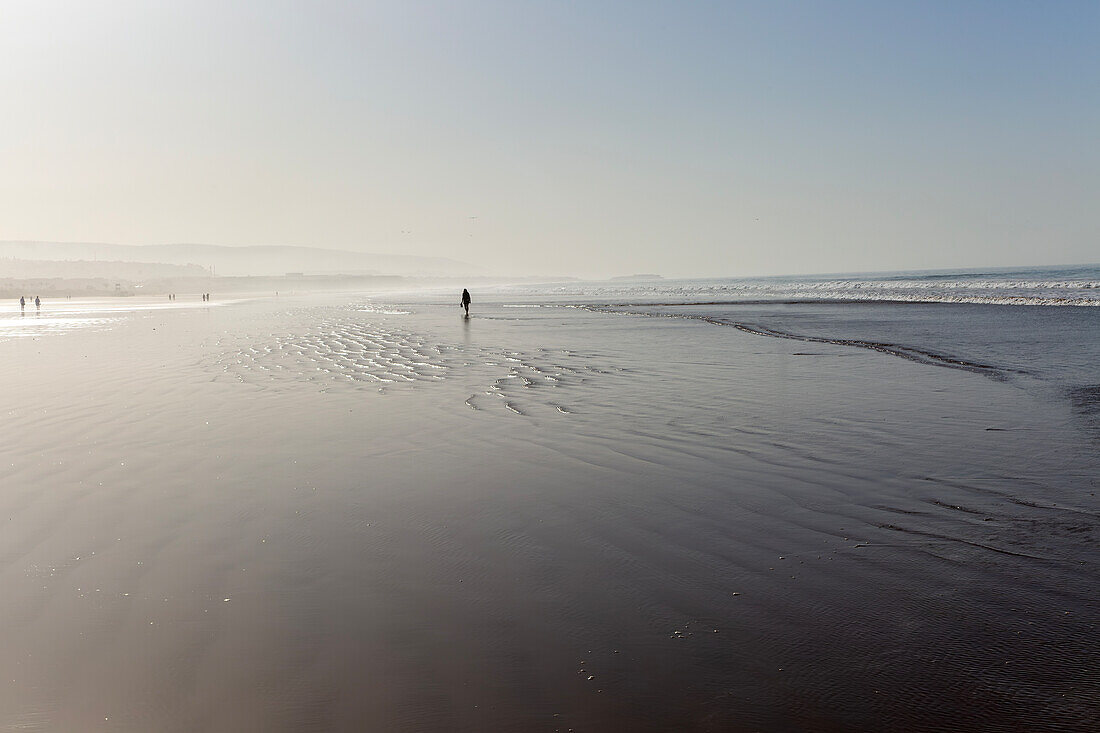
<box><xmin>0</xmin><ymin>241</ymin><xmax>481</xmax><ymax>277</ymax></box>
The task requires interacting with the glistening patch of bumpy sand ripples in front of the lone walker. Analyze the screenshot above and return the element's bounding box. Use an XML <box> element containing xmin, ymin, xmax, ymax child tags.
<box><xmin>207</xmin><ymin>317</ymin><xmax>628</xmax><ymax>415</ymax></box>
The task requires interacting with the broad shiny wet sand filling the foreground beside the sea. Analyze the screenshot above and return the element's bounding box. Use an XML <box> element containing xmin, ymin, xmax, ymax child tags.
<box><xmin>0</xmin><ymin>297</ymin><xmax>1100</xmax><ymax>731</ymax></box>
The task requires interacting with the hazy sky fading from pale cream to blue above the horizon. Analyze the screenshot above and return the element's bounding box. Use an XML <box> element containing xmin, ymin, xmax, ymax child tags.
<box><xmin>0</xmin><ymin>0</ymin><xmax>1100</xmax><ymax>275</ymax></box>
